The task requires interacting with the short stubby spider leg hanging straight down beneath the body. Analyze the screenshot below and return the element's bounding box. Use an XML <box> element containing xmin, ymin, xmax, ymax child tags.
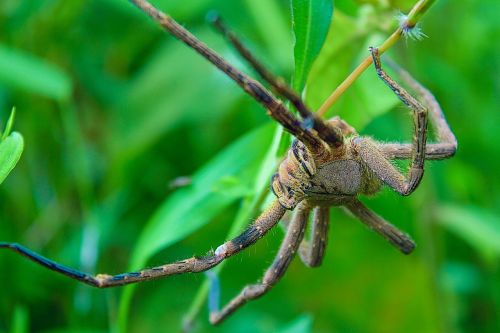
<box><xmin>299</xmin><ymin>207</ymin><xmax>330</xmax><ymax>267</ymax></box>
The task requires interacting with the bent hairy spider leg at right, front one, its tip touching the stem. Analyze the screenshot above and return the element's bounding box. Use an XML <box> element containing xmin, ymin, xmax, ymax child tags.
<box><xmin>352</xmin><ymin>48</ymin><xmax>427</xmax><ymax>195</ymax></box>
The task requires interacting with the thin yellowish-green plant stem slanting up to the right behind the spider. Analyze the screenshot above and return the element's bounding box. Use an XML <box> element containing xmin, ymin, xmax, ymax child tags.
<box><xmin>317</xmin><ymin>0</ymin><xmax>436</xmax><ymax>117</ymax></box>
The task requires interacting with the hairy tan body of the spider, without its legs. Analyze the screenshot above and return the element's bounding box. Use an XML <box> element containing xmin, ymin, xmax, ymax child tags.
<box><xmin>271</xmin><ymin>132</ymin><xmax>382</xmax><ymax>210</ymax></box>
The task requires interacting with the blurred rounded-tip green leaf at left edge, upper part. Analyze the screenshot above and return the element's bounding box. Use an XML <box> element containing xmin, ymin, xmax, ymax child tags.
<box><xmin>0</xmin><ymin>44</ymin><xmax>72</xmax><ymax>100</ymax></box>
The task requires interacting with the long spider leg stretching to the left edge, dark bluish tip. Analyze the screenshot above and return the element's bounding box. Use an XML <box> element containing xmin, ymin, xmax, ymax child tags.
<box><xmin>0</xmin><ymin>200</ymin><xmax>286</xmax><ymax>288</ymax></box>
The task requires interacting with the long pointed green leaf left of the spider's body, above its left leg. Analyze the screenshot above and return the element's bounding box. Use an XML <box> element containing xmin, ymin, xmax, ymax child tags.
<box><xmin>119</xmin><ymin>125</ymin><xmax>273</xmax><ymax>330</ymax></box>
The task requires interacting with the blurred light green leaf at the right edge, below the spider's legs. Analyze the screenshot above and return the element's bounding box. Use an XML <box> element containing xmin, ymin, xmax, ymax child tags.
<box><xmin>436</xmin><ymin>205</ymin><xmax>500</xmax><ymax>259</ymax></box>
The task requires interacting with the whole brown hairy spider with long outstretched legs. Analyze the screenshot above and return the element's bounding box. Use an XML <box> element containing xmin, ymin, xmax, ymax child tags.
<box><xmin>0</xmin><ymin>0</ymin><xmax>457</xmax><ymax>324</ymax></box>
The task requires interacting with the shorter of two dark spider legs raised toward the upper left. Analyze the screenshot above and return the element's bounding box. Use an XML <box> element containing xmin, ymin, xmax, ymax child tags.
<box><xmin>210</xmin><ymin>14</ymin><xmax>343</xmax><ymax>147</ymax></box>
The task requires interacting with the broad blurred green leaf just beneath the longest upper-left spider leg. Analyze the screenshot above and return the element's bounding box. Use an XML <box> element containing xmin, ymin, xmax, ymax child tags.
<box><xmin>109</xmin><ymin>31</ymin><xmax>242</xmax><ymax>167</ymax></box>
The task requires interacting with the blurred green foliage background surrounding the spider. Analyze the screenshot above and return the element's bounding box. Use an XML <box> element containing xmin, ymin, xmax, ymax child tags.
<box><xmin>0</xmin><ymin>0</ymin><xmax>500</xmax><ymax>332</ymax></box>
